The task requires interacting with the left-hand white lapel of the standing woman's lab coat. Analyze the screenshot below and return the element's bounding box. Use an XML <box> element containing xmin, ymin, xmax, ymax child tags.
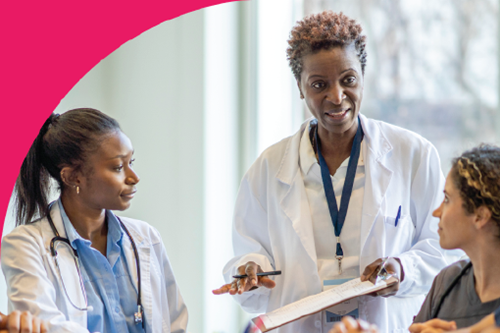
<box><xmin>276</xmin><ymin>121</ymin><xmax>317</xmax><ymax>262</ymax></box>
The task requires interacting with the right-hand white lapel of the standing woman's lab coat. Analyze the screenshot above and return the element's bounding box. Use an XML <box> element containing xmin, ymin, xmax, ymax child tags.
<box><xmin>360</xmin><ymin>115</ymin><xmax>392</xmax><ymax>252</ymax></box>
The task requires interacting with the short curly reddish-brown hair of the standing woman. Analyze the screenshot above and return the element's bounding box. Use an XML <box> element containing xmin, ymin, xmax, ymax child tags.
<box><xmin>286</xmin><ymin>10</ymin><xmax>367</xmax><ymax>80</ymax></box>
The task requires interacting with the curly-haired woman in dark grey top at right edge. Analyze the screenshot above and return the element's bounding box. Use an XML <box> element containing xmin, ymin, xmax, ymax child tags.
<box><xmin>330</xmin><ymin>145</ymin><xmax>500</xmax><ymax>333</ymax></box>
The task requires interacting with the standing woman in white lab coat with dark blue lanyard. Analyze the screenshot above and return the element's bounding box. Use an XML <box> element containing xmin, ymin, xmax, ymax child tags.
<box><xmin>214</xmin><ymin>11</ymin><xmax>456</xmax><ymax>333</ymax></box>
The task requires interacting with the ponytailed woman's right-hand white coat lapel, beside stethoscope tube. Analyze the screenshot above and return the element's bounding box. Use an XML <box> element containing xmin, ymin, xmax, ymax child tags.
<box><xmin>122</xmin><ymin>219</ymin><xmax>153</xmax><ymax>323</ymax></box>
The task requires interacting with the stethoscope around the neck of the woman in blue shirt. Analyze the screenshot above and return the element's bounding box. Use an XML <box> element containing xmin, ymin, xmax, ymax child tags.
<box><xmin>47</xmin><ymin>202</ymin><xmax>144</xmax><ymax>329</ymax></box>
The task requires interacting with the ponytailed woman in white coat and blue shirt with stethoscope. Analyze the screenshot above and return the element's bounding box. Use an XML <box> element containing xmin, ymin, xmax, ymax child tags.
<box><xmin>1</xmin><ymin>109</ymin><xmax>187</xmax><ymax>333</ymax></box>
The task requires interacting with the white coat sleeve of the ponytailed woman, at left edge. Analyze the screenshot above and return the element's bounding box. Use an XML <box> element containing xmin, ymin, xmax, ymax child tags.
<box><xmin>1</xmin><ymin>226</ymin><xmax>89</xmax><ymax>333</ymax></box>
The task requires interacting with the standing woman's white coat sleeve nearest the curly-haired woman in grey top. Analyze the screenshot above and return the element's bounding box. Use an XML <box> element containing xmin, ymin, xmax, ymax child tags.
<box><xmin>397</xmin><ymin>145</ymin><xmax>461</xmax><ymax>296</ymax></box>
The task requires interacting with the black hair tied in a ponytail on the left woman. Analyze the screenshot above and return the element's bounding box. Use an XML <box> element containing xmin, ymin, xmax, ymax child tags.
<box><xmin>15</xmin><ymin>108</ymin><xmax>120</xmax><ymax>225</ymax></box>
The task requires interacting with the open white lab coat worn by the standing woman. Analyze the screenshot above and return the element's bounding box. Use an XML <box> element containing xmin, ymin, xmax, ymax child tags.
<box><xmin>224</xmin><ymin>115</ymin><xmax>459</xmax><ymax>333</ymax></box>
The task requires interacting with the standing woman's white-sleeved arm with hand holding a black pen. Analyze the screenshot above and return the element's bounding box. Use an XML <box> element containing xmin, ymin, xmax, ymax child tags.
<box><xmin>214</xmin><ymin>170</ymin><xmax>275</xmax><ymax>312</ymax></box>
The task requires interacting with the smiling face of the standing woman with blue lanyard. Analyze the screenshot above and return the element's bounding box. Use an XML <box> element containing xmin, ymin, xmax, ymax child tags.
<box><xmin>297</xmin><ymin>43</ymin><xmax>363</xmax><ymax>134</ymax></box>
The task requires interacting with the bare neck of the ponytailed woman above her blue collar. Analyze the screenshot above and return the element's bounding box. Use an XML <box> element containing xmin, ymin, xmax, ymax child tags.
<box><xmin>61</xmin><ymin>193</ymin><xmax>108</xmax><ymax>243</ymax></box>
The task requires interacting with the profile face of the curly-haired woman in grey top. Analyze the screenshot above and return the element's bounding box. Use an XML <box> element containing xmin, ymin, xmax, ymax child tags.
<box><xmin>432</xmin><ymin>171</ymin><xmax>476</xmax><ymax>249</ymax></box>
